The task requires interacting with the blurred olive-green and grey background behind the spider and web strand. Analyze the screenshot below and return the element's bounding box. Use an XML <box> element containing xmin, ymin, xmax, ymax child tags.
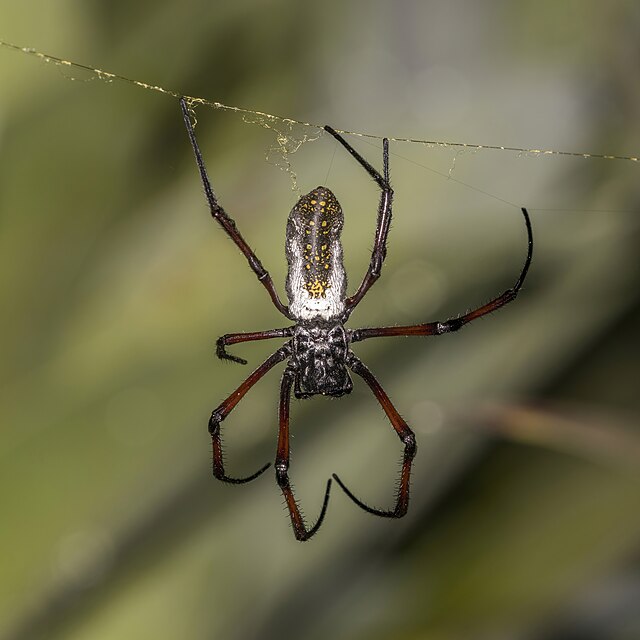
<box><xmin>0</xmin><ymin>0</ymin><xmax>640</xmax><ymax>640</ymax></box>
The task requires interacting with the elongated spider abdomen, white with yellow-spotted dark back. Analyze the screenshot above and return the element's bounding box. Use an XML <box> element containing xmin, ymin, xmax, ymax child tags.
<box><xmin>286</xmin><ymin>187</ymin><xmax>347</xmax><ymax>320</ymax></box>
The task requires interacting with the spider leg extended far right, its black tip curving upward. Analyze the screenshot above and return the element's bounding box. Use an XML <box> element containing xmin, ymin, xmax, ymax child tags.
<box><xmin>351</xmin><ymin>207</ymin><xmax>533</xmax><ymax>342</ymax></box>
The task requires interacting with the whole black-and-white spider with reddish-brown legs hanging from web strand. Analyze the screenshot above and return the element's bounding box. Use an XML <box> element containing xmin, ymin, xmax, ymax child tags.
<box><xmin>180</xmin><ymin>98</ymin><xmax>533</xmax><ymax>541</ymax></box>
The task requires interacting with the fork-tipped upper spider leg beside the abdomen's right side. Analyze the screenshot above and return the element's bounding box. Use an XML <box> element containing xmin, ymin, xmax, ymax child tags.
<box><xmin>324</xmin><ymin>125</ymin><xmax>393</xmax><ymax>317</ymax></box>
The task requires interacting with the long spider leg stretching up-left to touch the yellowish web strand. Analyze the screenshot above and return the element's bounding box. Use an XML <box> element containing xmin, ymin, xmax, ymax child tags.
<box><xmin>180</xmin><ymin>98</ymin><xmax>289</xmax><ymax>318</ymax></box>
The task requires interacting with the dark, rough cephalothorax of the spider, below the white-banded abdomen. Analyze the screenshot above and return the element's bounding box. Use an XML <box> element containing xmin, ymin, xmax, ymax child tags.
<box><xmin>291</xmin><ymin>320</ymin><xmax>353</xmax><ymax>398</ymax></box>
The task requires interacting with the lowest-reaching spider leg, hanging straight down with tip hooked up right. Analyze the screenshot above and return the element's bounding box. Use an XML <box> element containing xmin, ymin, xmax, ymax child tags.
<box><xmin>275</xmin><ymin>367</ymin><xmax>331</xmax><ymax>542</ymax></box>
